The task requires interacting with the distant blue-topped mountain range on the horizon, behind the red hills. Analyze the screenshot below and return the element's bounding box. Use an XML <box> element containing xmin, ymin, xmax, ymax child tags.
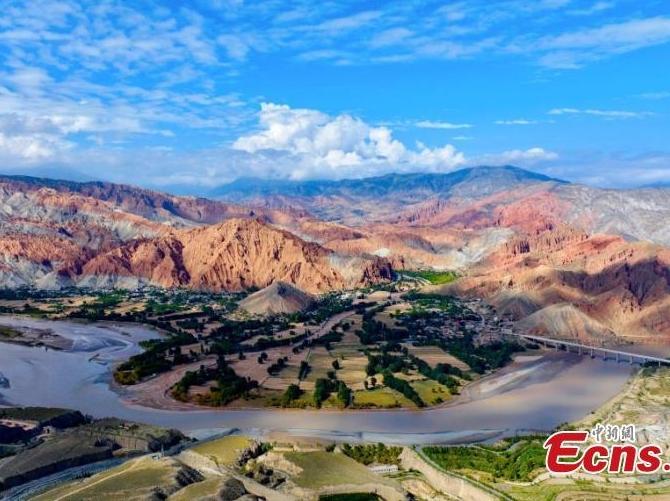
<box><xmin>211</xmin><ymin>166</ymin><xmax>670</xmax><ymax>245</ymax></box>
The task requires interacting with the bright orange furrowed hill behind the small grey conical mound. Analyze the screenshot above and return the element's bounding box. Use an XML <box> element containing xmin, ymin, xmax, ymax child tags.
<box><xmin>81</xmin><ymin>219</ymin><xmax>392</xmax><ymax>292</ymax></box>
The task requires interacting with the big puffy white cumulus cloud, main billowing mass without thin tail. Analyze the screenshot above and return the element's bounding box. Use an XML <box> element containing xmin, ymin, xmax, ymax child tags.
<box><xmin>232</xmin><ymin>103</ymin><xmax>465</xmax><ymax>178</ymax></box>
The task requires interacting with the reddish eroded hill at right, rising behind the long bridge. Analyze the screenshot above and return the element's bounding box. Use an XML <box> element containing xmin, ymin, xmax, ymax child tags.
<box><xmin>452</xmin><ymin>227</ymin><xmax>670</xmax><ymax>340</ymax></box>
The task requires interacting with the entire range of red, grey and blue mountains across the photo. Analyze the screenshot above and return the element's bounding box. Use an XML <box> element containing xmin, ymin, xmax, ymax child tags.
<box><xmin>0</xmin><ymin>166</ymin><xmax>670</xmax><ymax>339</ymax></box>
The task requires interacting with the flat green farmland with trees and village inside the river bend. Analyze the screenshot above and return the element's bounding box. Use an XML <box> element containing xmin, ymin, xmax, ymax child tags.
<box><xmin>0</xmin><ymin>284</ymin><xmax>523</xmax><ymax>410</ymax></box>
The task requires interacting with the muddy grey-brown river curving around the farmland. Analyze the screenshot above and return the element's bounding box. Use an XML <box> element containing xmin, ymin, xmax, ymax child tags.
<box><xmin>0</xmin><ymin>316</ymin><xmax>632</xmax><ymax>443</ymax></box>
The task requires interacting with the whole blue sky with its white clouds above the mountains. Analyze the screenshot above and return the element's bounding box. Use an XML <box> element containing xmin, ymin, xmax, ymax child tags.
<box><xmin>0</xmin><ymin>0</ymin><xmax>670</xmax><ymax>193</ymax></box>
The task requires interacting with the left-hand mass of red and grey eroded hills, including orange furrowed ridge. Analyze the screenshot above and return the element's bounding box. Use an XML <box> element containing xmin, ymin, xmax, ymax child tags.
<box><xmin>0</xmin><ymin>177</ymin><xmax>391</xmax><ymax>292</ymax></box>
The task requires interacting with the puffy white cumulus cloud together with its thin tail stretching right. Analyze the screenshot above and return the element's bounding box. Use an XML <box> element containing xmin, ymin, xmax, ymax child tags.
<box><xmin>227</xmin><ymin>103</ymin><xmax>558</xmax><ymax>179</ymax></box>
